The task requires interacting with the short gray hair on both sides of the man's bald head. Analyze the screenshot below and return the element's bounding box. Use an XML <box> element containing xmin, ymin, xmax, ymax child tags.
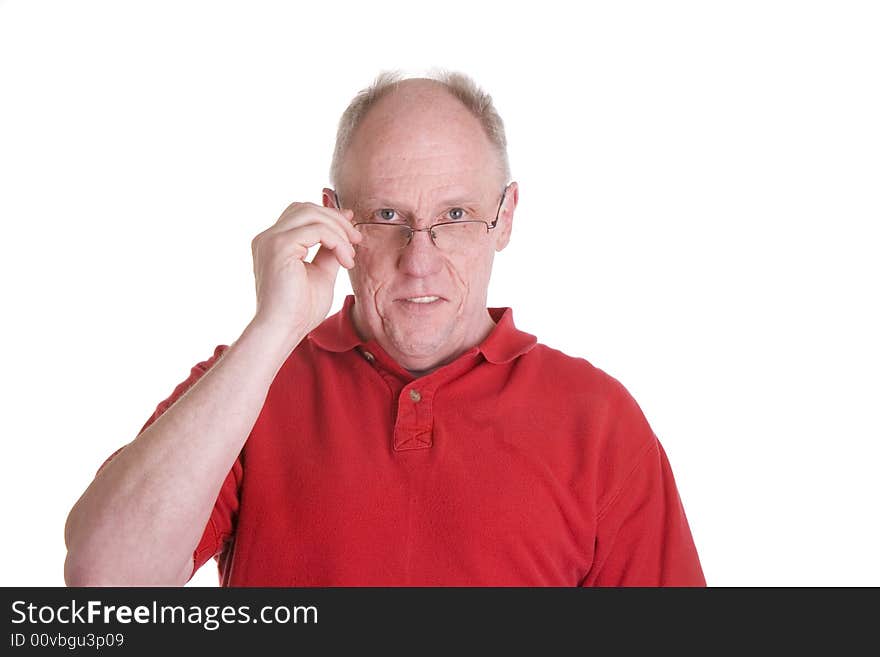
<box><xmin>330</xmin><ymin>71</ymin><xmax>510</xmax><ymax>185</ymax></box>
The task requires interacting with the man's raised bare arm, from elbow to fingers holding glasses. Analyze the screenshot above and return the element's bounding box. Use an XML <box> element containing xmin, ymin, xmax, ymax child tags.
<box><xmin>64</xmin><ymin>203</ymin><xmax>360</xmax><ymax>586</ymax></box>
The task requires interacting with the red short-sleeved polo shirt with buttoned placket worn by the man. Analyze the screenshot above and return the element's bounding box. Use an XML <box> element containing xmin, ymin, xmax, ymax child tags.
<box><xmin>125</xmin><ymin>296</ymin><xmax>705</xmax><ymax>586</ymax></box>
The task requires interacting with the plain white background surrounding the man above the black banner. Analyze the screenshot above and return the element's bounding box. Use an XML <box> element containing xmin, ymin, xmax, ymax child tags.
<box><xmin>0</xmin><ymin>0</ymin><xmax>880</xmax><ymax>586</ymax></box>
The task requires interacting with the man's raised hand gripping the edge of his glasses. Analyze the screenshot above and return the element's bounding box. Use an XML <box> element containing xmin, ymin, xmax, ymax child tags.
<box><xmin>251</xmin><ymin>203</ymin><xmax>362</xmax><ymax>348</ymax></box>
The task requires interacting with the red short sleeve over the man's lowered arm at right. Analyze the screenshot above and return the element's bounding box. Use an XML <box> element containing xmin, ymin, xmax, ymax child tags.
<box><xmin>582</xmin><ymin>382</ymin><xmax>706</xmax><ymax>587</ymax></box>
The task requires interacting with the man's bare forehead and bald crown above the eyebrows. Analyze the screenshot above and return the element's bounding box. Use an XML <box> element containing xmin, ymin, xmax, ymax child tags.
<box><xmin>342</xmin><ymin>81</ymin><xmax>499</xmax><ymax>197</ymax></box>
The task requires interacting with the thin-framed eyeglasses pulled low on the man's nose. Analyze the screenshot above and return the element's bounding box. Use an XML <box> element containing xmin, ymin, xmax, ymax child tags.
<box><xmin>333</xmin><ymin>187</ymin><xmax>507</xmax><ymax>253</ymax></box>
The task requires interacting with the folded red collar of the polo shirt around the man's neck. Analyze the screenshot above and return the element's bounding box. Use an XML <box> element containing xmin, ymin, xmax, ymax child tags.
<box><xmin>309</xmin><ymin>294</ymin><xmax>538</xmax><ymax>364</ymax></box>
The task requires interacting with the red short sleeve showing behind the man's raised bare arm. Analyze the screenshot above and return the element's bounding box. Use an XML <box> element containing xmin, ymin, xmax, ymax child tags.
<box><xmin>98</xmin><ymin>345</ymin><xmax>242</xmax><ymax>577</ymax></box>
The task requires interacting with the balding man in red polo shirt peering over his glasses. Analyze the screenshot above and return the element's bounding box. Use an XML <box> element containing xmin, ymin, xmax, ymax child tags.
<box><xmin>65</xmin><ymin>70</ymin><xmax>705</xmax><ymax>586</ymax></box>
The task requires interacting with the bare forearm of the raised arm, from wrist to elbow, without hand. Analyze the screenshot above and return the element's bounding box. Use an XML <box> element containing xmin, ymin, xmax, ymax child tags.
<box><xmin>65</xmin><ymin>323</ymin><xmax>300</xmax><ymax>585</ymax></box>
